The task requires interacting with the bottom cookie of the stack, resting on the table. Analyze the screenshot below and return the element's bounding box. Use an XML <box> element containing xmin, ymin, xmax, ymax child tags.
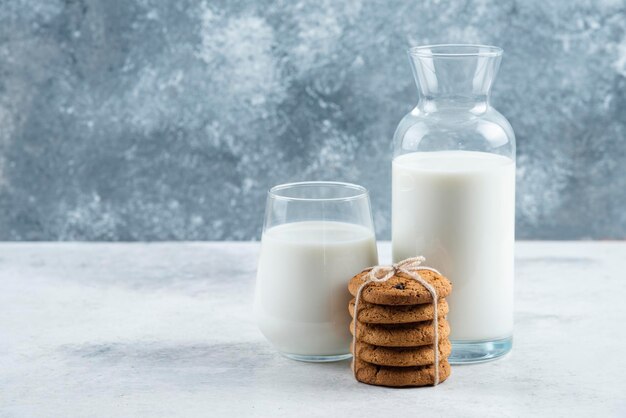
<box><xmin>353</xmin><ymin>360</ymin><xmax>451</xmax><ymax>387</ymax></box>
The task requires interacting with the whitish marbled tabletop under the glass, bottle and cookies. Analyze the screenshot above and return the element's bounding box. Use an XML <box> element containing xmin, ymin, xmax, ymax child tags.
<box><xmin>0</xmin><ymin>242</ymin><xmax>626</xmax><ymax>418</ymax></box>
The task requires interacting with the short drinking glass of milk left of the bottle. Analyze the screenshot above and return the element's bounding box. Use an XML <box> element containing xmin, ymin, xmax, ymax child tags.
<box><xmin>254</xmin><ymin>182</ymin><xmax>378</xmax><ymax>362</ymax></box>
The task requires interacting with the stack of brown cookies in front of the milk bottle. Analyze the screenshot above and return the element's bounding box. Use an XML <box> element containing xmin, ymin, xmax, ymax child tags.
<box><xmin>348</xmin><ymin>270</ymin><xmax>452</xmax><ymax>387</ymax></box>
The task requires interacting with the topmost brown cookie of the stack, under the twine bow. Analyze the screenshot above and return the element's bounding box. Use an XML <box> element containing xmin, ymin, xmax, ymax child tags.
<box><xmin>348</xmin><ymin>270</ymin><xmax>452</xmax><ymax>306</ymax></box>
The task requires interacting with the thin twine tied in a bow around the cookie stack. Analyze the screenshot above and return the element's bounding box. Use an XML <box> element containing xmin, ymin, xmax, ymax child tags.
<box><xmin>352</xmin><ymin>256</ymin><xmax>441</xmax><ymax>386</ymax></box>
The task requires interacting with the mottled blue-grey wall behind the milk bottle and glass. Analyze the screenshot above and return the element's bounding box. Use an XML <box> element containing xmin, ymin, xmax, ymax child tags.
<box><xmin>0</xmin><ymin>0</ymin><xmax>626</xmax><ymax>240</ymax></box>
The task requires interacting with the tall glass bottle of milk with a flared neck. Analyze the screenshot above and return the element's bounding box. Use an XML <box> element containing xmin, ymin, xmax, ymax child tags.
<box><xmin>392</xmin><ymin>45</ymin><xmax>515</xmax><ymax>363</ymax></box>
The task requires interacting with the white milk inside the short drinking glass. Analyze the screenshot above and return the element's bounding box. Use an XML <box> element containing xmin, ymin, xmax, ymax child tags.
<box><xmin>255</xmin><ymin>221</ymin><xmax>378</xmax><ymax>356</ymax></box>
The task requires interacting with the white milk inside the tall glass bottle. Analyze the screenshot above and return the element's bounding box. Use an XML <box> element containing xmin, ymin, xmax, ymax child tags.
<box><xmin>392</xmin><ymin>151</ymin><xmax>515</xmax><ymax>341</ymax></box>
